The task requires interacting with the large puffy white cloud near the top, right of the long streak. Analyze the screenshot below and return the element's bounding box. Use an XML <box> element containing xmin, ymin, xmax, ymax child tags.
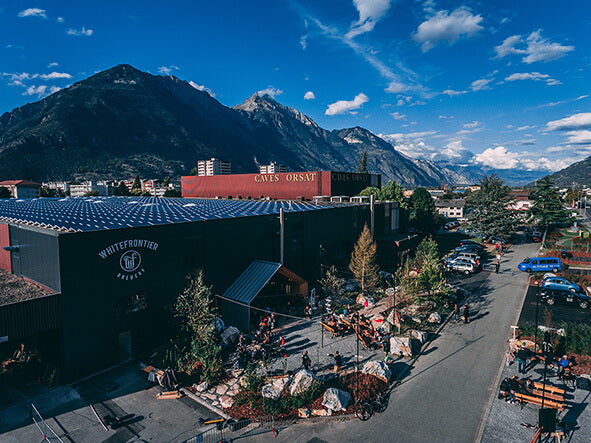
<box><xmin>413</xmin><ymin>7</ymin><xmax>483</xmax><ymax>52</ymax></box>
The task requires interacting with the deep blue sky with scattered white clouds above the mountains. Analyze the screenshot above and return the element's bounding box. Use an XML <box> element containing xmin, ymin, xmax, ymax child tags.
<box><xmin>0</xmin><ymin>0</ymin><xmax>591</xmax><ymax>175</ymax></box>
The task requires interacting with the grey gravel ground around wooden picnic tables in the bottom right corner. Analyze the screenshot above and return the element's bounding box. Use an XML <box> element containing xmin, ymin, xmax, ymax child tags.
<box><xmin>482</xmin><ymin>363</ymin><xmax>591</xmax><ymax>443</ymax></box>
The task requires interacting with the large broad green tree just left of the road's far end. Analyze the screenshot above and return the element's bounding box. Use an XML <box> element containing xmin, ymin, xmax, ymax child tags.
<box><xmin>468</xmin><ymin>174</ymin><xmax>517</xmax><ymax>239</ymax></box>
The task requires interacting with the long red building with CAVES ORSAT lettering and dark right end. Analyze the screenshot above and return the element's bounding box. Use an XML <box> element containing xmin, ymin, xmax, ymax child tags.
<box><xmin>181</xmin><ymin>171</ymin><xmax>381</xmax><ymax>200</ymax></box>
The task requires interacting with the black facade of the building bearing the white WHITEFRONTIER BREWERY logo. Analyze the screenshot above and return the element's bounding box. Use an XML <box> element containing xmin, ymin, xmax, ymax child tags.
<box><xmin>0</xmin><ymin>199</ymin><xmax>397</xmax><ymax>379</ymax></box>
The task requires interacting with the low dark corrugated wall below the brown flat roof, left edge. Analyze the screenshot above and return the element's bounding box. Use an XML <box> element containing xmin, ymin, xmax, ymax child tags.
<box><xmin>0</xmin><ymin>294</ymin><xmax>62</xmax><ymax>340</ymax></box>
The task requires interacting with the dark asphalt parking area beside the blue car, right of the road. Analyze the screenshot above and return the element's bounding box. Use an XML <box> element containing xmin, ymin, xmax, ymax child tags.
<box><xmin>519</xmin><ymin>286</ymin><xmax>591</xmax><ymax>328</ymax></box>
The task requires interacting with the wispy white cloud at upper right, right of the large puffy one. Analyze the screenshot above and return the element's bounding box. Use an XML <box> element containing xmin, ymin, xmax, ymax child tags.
<box><xmin>495</xmin><ymin>29</ymin><xmax>575</xmax><ymax>64</ymax></box>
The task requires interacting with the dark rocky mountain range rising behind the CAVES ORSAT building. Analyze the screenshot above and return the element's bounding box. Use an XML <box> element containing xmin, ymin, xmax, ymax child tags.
<box><xmin>0</xmin><ymin>65</ymin><xmax>475</xmax><ymax>186</ymax></box>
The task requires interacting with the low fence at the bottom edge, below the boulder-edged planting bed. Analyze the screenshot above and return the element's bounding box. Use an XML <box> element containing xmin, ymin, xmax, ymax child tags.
<box><xmin>184</xmin><ymin>415</ymin><xmax>277</xmax><ymax>443</ymax></box>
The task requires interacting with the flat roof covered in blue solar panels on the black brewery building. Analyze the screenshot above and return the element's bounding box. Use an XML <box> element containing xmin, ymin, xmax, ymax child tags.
<box><xmin>0</xmin><ymin>197</ymin><xmax>356</xmax><ymax>232</ymax></box>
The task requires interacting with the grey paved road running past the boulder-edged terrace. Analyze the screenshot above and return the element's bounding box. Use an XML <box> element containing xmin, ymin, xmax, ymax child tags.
<box><xmin>263</xmin><ymin>238</ymin><xmax>537</xmax><ymax>442</ymax></box>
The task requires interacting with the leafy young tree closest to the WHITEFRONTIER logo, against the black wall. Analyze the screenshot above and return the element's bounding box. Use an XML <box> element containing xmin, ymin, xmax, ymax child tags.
<box><xmin>174</xmin><ymin>273</ymin><xmax>224</xmax><ymax>383</ymax></box>
